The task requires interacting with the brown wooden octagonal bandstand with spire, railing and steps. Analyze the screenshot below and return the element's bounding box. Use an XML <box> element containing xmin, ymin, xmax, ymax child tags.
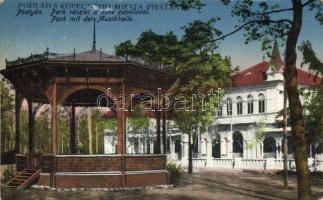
<box><xmin>1</xmin><ymin>22</ymin><xmax>174</xmax><ymax>188</ymax></box>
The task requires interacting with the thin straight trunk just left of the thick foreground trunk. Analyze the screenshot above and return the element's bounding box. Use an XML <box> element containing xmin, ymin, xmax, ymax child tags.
<box><xmin>283</xmin><ymin>82</ymin><xmax>288</xmax><ymax>187</ymax></box>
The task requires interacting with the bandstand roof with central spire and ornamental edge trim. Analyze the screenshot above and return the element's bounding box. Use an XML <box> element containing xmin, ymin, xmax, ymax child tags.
<box><xmin>1</xmin><ymin>23</ymin><xmax>175</xmax><ymax>106</ymax></box>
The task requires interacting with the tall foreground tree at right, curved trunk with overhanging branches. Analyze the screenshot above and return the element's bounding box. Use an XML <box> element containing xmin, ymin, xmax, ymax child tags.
<box><xmin>170</xmin><ymin>0</ymin><xmax>323</xmax><ymax>199</ymax></box>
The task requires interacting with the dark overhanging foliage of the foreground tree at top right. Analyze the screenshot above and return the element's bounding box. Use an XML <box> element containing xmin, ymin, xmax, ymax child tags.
<box><xmin>169</xmin><ymin>0</ymin><xmax>323</xmax><ymax>50</ymax></box>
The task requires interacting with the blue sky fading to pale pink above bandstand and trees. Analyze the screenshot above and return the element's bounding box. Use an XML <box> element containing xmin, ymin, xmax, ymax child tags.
<box><xmin>0</xmin><ymin>0</ymin><xmax>323</xmax><ymax>69</ymax></box>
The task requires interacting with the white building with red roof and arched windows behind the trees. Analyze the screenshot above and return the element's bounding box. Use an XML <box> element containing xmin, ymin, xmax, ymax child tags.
<box><xmin>105</xmin><ymin>43</ymin><xmax>323</xmax><ymax>170</ymax></box>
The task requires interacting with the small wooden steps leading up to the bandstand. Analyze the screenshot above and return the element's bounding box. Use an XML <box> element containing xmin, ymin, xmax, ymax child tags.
<box><xmin>6</xmin><ymin>169</ymin><xmax>41</xmax><ymax>190</ymax></box>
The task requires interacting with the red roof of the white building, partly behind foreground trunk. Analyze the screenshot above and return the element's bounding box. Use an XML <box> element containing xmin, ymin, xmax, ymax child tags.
<box><xmin>233</xmin><ymin>61</ymin><xmax>322</xmax><ymax>86</ymax></box>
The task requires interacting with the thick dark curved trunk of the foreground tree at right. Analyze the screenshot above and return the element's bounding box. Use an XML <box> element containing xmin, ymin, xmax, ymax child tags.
<box><xmin>285</xmin><ymin>0</ymin><xmax>311</xmax><ymax>200</ymax></box>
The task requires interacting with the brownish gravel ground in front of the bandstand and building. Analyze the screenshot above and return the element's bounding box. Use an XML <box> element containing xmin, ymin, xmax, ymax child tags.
<box><xmin>1</xmin><ymin>170</ymin><xmax>323</xmax><ymax>200</ymax></box>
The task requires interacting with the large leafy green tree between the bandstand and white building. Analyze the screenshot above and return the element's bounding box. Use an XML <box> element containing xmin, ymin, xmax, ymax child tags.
<box><xmin>116</xmin><ymin>18</ymin><xmax>233</xmax><ymax>172</ymax></box>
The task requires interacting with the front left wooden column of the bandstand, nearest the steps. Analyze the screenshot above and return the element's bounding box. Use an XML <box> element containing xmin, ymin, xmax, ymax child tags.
<box><xmin>51</xmin><ymin>81</ymin><xmax>57</xmax><ymax>155</ymax></box>
